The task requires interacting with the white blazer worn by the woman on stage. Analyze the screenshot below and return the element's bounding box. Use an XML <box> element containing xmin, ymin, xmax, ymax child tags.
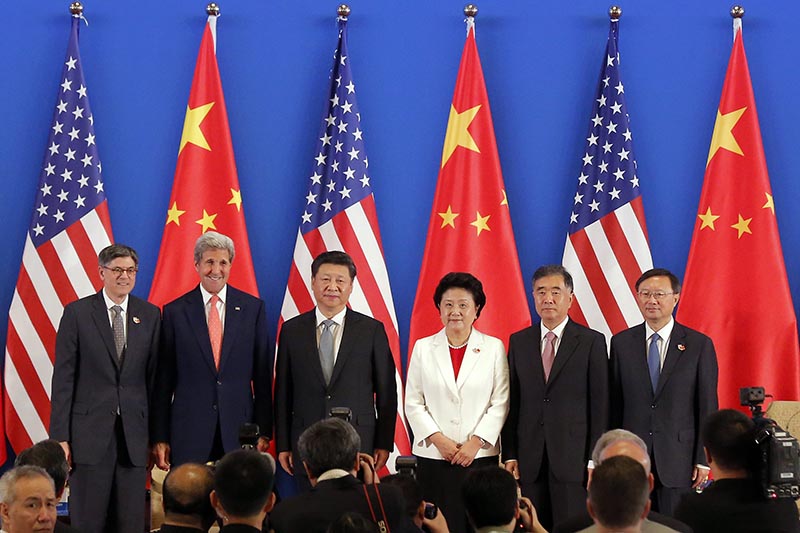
<box><xmin>406</xmin><ymin>328</ymin><xmax>509</xmax><ymax>459</ymax></box>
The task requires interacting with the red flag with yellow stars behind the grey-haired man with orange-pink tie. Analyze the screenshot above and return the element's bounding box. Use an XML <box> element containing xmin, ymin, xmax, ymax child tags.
<box><xmin>150</xmin><ymin>15</ymin><xmax>258</xmax><ymax>306</ymax></box>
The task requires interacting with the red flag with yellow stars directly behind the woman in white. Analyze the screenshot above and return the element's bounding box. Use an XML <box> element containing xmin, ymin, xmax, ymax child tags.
<box><xmin>408</xmin><ymin>17</ymin><xmax>531</xmax><ymax>354</ymax></box>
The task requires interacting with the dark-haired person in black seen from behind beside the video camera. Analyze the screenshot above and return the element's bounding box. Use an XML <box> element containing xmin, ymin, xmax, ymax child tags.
<box><xmin>675</xmin><ymin>409</ymin><xmax>800</xmax><ymax>533</ymax></box>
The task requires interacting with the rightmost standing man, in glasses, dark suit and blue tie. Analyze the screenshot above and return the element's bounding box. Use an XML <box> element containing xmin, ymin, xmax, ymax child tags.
<box><xmin>611</xmin><ymin>268</ymin><xmax>717</xmax><ymax>516</ymax></box>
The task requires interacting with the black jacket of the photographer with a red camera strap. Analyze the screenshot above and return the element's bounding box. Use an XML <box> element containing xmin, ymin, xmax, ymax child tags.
<box><xmin>270</xmin><ymin>476</ymin><xmax>405</xmax><ymax>533</ymax></box>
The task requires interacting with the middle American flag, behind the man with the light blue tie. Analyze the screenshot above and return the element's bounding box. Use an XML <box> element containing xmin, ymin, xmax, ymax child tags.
<box><xmin>281</xmin><ymin>18</ymin><xmax>410</xmax><ymax>465</ymax></box>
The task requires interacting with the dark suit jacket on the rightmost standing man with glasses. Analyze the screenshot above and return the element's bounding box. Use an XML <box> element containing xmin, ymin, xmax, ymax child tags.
<box><xmin>610</xmin><ymin>322</ymin><xmax>717</xmax><ymax>488</ymax></box>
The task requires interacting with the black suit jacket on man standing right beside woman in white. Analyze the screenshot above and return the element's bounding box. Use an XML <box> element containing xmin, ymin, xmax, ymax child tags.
<box><xmin>502</xmin><ymin>320</ymin><xmax>608</xmax><ymax>483</ymax></box>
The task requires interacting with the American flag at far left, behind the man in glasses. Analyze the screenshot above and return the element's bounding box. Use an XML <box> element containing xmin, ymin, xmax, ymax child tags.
<box><xmin>3</xmin><ymin>15</ymin><xmax>112</xmax><ymax>460</ymax></box>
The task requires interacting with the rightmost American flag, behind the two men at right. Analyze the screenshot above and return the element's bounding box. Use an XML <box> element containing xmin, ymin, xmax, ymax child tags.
<box><xmin>563</xmin><ymin>20</ymin><xmax>653</xmax><ymax>340</ymax></box>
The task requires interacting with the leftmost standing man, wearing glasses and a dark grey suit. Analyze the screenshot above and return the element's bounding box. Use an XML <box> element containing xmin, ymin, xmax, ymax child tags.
<box><xmin>50</xmin><ymin>244</ymin><xmax>160</xmax><ymax>533</ymax></box>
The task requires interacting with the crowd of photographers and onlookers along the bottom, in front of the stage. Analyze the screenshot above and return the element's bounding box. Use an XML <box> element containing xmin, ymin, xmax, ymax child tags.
<box><xmin>0</xmin><ymin>409</ymin><xmax>800</xmax><ymax>533</ymax></box>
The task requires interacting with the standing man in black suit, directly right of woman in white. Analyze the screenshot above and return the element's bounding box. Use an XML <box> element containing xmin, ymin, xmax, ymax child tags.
<box><xmin>502</xmin><ymin>265</ymin><xmax>608</xmax><ymax>530</ymax></box>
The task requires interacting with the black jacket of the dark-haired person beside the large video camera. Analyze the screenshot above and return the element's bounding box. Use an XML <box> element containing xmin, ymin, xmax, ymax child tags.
<box><xmin>675</xmin><ymin>479</ymin><xmax>800</xmax><ymax>533</ymax></box>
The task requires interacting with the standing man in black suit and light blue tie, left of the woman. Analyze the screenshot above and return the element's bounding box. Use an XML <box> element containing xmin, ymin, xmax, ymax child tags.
<box><xmin>275</xmin><ymin>251</ymin><xmax>397</xmax><ymax>490</ymax></box>
